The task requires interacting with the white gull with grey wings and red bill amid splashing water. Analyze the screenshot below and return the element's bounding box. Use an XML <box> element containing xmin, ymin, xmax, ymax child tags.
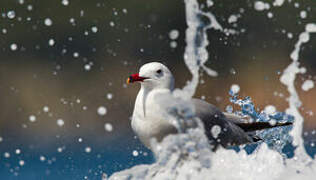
<box><xmin>127</xmin><ymin>62</ymin><xmax>292</xmax><ymax>150</ymax></box>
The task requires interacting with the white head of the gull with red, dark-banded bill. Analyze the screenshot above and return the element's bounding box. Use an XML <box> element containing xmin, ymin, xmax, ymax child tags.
<box><xmin>127</xmin><ymin>62</ymin><xmax>174</xmax><ymax>90</ymax></box>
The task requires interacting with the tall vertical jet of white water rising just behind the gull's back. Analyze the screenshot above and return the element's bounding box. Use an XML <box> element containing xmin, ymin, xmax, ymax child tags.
<box><xmin>177</xmin><ymin>0</ymin><xmax>223</xmax><ymax>98</ymax></box>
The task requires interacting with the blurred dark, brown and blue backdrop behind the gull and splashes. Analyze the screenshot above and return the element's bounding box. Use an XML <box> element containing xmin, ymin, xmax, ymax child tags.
<box><xmin>0</xmin><ymin>0</ymin><xmax>316</xmax><ymax>179</ymax></box>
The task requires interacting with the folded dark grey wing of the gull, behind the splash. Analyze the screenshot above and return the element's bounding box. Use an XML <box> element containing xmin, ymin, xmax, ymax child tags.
<box><xmin>192</xmin><ymin>99</ymin><xmax>253</xmax><ymax>149</ymax></box>
